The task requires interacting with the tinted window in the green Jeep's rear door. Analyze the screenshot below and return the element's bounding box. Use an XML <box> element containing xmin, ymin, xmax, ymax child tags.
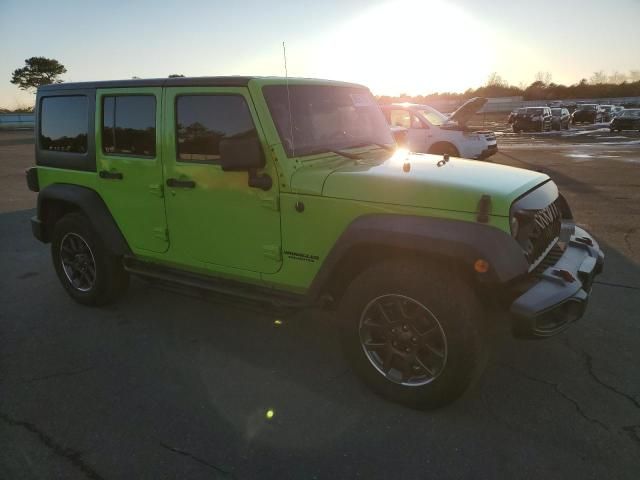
<box><xmin>102</xmin><ymin>95</ymin><xmax>156</xmax><ymax>157</ymax></box>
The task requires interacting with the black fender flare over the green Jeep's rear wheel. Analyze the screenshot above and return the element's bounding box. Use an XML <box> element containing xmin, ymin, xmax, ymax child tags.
<box><xmin>38</xmin><ymin>183</ymin><xmax>131</xmax><ymax>256</ymax></box>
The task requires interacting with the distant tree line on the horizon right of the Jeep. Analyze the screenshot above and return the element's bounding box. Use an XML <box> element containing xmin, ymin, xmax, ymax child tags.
<box><xmin>378</xmin><ymin>70</ymin><xmax>640</xmax><ymax>103</ymax></box>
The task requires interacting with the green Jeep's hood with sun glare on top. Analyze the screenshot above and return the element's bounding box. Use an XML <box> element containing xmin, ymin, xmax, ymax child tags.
<box><xmin>292</xmin><ymin>151</ymin><xmax>549</xmax><ymax>216</ymax></box>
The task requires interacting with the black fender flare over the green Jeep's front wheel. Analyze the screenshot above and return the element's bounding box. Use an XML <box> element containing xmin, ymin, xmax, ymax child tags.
<box><xmin>309</xmin><ymin>214</ymin><xmax>529</xmax><ymax>297</ymax></box>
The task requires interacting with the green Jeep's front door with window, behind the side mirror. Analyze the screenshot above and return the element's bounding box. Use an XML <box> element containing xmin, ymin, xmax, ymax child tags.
<box><xmin>164</xmin><ymin>87</ymin><xmax>281</xmax><ymax>274</ymax></box>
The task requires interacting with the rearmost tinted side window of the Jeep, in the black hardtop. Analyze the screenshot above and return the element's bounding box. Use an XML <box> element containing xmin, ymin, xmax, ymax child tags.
<box><xmin>40</xmin><ymin>96</ymin><xmax>89</xmax><ymax>153</ymax></box>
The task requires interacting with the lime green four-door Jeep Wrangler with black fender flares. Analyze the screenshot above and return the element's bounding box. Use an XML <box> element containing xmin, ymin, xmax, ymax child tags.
<box><xmin>27</xmin><ymin>77</ymin><xmax>604</xmax><ymax>408</ymax></box>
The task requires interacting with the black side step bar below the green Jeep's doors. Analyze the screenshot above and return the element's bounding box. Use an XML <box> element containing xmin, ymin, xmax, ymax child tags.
<box><xmin>124</xmin><ymin>257</ymin><xmax>314</xmax><ymax>309</ymax></box>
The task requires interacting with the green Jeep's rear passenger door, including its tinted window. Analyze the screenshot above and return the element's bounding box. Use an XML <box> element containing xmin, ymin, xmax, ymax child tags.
<box><xmin>95</xmin><ymin>88</ymin><xmax>169</xmax><ymax>254</ymax></box>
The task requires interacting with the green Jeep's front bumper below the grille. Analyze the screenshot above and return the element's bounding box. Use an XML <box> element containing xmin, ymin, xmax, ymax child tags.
<box><xmin>511</xmin><ymin>227</ymin><xmax>604</xmax><ymax>338</ymax></box>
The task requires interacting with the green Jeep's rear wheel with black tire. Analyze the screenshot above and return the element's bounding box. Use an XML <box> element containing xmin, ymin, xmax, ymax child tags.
<box><xmin>51</xmin><ymin>212</ymin><xmax>129</xmax><ymax>306</ymax></box>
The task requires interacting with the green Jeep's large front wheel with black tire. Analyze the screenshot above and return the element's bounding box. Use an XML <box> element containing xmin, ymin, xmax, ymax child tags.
<box><xmin>339</xmin><ymin>261</ymin><xmax>483</xmax><ymax>409</ymax></box>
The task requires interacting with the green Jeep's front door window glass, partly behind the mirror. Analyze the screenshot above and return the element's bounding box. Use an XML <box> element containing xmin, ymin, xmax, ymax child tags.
<box><xmin>176</xmin><ymin>95</ymin><xmax>257</xmax><ymax>162</ymax></box>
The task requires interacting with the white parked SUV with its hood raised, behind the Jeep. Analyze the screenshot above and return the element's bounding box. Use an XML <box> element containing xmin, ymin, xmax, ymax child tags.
<box><xmin>382</xmin><ymin>98</ymin><xmax>498</xmax><ymax>159</ymax></box>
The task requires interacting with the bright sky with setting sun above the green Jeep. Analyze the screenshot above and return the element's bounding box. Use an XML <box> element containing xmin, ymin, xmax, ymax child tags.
<box><xmin>0</xmin><ymin>0</ymin><xmax>640</xmax><ymax>108</ymax></box>
